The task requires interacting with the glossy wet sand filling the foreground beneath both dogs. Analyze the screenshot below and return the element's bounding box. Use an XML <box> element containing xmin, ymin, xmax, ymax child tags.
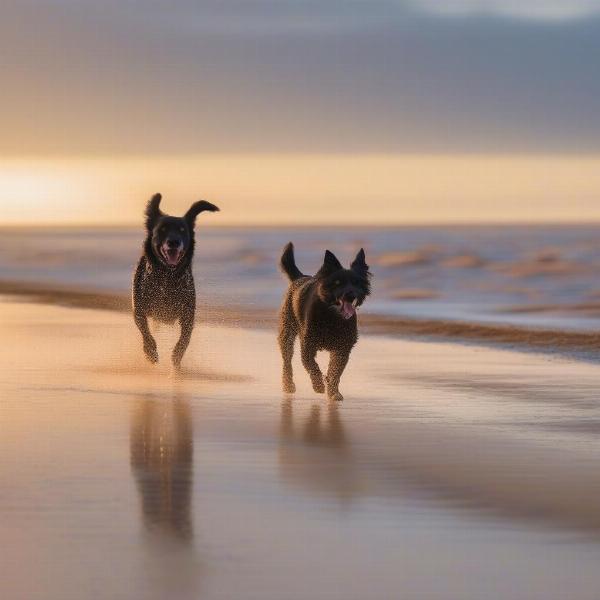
<box><xmin>0</xmin><ymin>297</ymin><xmax>600</xmax><ymax>600</ymax></box>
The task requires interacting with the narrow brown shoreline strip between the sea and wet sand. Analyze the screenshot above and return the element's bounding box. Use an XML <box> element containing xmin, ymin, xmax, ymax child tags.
<box><xmin>0</xmin><ymin>280</ymin><xmax>600</xmax><ymax>360</ymax></box>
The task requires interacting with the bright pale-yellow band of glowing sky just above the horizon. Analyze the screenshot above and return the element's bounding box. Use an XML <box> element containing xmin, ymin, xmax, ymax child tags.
<box><xmin>0</xmin><ymin>154</ymin><xmax>600</xmax><ymax>225</ymax></box>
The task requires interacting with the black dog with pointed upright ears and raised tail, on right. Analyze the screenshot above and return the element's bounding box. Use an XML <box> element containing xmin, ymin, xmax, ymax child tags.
<box><xmin>279</xmin><ymin>242</ymin><xmax>371</xmax><ymax>400</ymax></box>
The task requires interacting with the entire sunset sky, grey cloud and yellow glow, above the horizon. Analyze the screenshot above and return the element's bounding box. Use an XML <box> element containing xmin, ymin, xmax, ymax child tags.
<box><xmin>0</xmin><ymin>0</ymin><xmax>600</xmax><ymax>223</ymax></box>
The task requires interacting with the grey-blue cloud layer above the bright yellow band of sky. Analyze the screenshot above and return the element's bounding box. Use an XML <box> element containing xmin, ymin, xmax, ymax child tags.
<box><xmin>0</xmin><ymin>0</ymin><xmax>600</xmax><ymax>154</ymax></box>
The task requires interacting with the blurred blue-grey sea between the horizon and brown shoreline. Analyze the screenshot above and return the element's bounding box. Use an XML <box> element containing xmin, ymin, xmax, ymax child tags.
<box><xmin>5</xmin><ymin>223</ymin><xmax>600</xmax><ymax>330</ymax></box>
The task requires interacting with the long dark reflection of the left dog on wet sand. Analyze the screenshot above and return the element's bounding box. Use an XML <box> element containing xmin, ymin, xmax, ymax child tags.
<box><xmin>130</xmin><ymin>396</ymin><xmax>194</xmax><ymax>540</ymax></box>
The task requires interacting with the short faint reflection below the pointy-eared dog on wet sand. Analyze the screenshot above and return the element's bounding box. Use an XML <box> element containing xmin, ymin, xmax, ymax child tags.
<box><xmin>279</xmin><ymin>398</ymin><xmax>362</xmax><ymax>503</ymax></box>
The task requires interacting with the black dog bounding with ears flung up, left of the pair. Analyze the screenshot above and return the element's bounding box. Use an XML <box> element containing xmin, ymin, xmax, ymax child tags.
<box><xmin>133</xmin><ymin>194</ymin><xmax>219</xmax><ymax>367</ymax></box>
